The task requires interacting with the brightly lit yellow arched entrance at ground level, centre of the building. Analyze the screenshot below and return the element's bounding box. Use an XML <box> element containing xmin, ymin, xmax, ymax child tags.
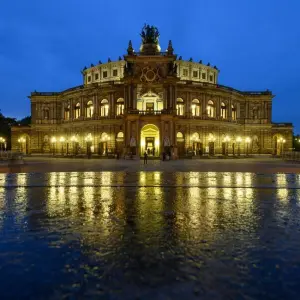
<box><xmin>141</xmin><ymin>124</ymin><xmax>160</xmax><ymax>156</ymax></box>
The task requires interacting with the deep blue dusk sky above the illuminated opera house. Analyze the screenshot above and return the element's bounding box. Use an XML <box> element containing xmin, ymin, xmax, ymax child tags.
<box><xmin>0</xmin><ymin>0</ymin><xmax>300</xmax><ymax>133</ymax></box>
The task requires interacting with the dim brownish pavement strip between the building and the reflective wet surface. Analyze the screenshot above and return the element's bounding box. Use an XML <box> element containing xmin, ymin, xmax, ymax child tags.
<box><xmin>0</xmin><ymin>157</ymin><xmax>300</xmax><ymax>174</ymax></box>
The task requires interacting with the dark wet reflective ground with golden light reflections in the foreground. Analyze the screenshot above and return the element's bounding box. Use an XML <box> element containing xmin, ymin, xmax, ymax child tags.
<box><xmin>0</xmin><ymin>170</ymin><xmax>300</xmax><ymax>299</ymax></box>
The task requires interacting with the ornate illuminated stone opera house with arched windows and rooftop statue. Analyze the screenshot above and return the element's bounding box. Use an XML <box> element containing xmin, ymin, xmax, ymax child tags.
<box><xmin>12</xmin><ymin>27</ymin><xmax>293</xmax><ymax>157</ymax></box>
